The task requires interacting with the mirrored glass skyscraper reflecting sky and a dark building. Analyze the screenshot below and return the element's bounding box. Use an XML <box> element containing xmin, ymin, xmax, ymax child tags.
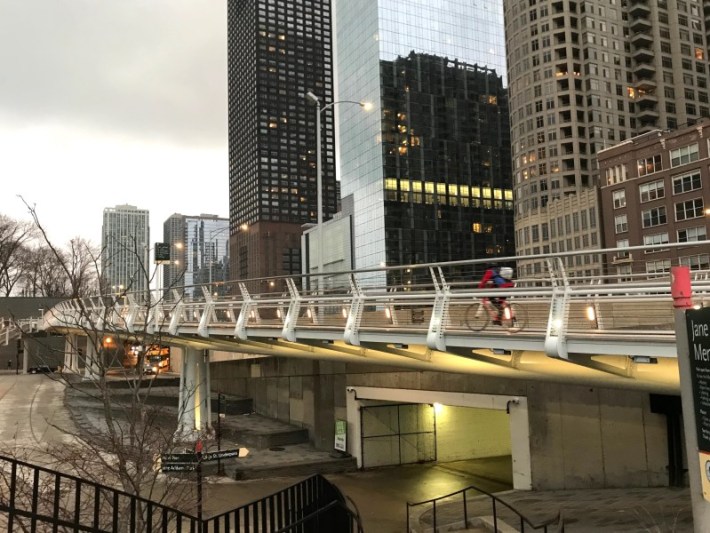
<box><xmin>334</xmin><ymin>0</ymin><xmax>513</xmax><ymax>274</ymax></box>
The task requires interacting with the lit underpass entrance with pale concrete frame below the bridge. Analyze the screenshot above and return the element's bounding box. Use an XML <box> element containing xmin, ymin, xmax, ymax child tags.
<box><xmin>347</xmin><ymin>387</ymin><xmax>532</xmax><ymax>490</ymax></box>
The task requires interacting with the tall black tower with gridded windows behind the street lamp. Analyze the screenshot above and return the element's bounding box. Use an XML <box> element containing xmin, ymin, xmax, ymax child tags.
<box><xmin>228</xmin><ymin>0</ymin><xmax>337</xmax><ymax>284</ymax></box>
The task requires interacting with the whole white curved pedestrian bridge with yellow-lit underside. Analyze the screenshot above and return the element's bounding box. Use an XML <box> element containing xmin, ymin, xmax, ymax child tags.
<box><xmin>6</xmin><ymin>245</ymin><xmax>710</xmax><ymax>392</ymax></box>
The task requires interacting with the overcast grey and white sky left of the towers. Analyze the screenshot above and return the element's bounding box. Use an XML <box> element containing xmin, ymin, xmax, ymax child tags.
<box><xmin>0</xmin><ymin>0</ymin><xmax>228</xmax><ymax>245</ymax></box>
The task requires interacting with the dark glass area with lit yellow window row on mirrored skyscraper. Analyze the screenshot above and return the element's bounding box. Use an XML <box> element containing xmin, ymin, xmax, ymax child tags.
<box><xmin>381</xmin><ymin>52</ymin><xmax>515</xmax><ymax>265</ymax></box>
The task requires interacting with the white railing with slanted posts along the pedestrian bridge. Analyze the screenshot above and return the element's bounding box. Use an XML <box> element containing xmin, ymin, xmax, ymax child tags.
<box><xmin>29</xmin><ymin>242</ymin><xmax>710</xmax><ymax>359</ymax></box>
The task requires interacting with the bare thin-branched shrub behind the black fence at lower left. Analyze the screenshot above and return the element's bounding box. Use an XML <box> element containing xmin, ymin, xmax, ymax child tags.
<box><xmin>2</xmin><ymin>206</ymin><xmax>200</xmax><ymax>532</ymax></box>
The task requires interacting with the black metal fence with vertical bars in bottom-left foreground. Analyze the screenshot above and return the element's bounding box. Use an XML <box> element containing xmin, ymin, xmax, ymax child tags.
<box><xmin>0</xmin><ymin>456</ymin><xmax>362</xmax><ymax>533</ymax></box>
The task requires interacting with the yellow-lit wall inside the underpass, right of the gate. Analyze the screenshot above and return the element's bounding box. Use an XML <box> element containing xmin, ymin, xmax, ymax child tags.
<box><xmin>436</xmin><ymin>405</ymin><xmax>511</xmax><ymax>462</ymax></box>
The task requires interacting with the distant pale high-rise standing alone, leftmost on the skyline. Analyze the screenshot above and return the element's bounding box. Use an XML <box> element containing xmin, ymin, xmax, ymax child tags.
<box><xmin>101</xmin><ymin>205</ymin><xmax>153</xmax><ymax>294</ymax></box>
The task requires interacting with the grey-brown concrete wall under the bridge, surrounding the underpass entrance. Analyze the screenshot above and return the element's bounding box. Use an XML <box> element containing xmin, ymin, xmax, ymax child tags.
<box><xmin>212</xmin><ymin>358</ymin><xmax>668</xmax><ymax>489</ymax></box>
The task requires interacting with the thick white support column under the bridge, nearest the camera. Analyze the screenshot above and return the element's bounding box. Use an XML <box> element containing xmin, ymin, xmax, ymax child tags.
<box><xmin>175</xmin><ymin>348</ymin><xmax>212</xmax><ymax>440</ymax></box>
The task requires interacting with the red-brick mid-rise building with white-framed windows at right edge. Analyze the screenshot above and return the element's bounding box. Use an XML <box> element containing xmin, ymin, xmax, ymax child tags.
<box><xmin>599</xmin><ymin>121</ymin><xmax>710</xmax><ymax>279</ymax></box>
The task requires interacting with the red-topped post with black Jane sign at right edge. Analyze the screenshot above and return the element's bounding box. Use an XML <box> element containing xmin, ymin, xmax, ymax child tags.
<box><xmin>671</xmin><ymin>266</ymin><xmax>710</xmax><ymax>533</ymax></box>
